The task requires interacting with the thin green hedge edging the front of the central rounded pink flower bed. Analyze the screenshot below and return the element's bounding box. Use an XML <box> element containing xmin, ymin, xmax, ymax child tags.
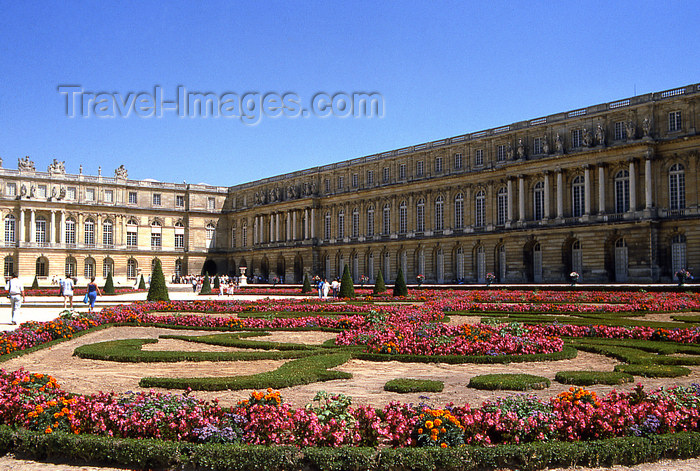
<box><xmin>355</xmin><ymin>346</ymin><xmax>577</xmax><ymax>364</ymax></box>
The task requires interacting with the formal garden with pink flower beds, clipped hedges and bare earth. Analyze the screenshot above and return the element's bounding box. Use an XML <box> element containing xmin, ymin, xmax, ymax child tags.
<box><xmin>0</xmin><ymin>278</ymin><xmax>700</xmax><ymax>470</ymax></box>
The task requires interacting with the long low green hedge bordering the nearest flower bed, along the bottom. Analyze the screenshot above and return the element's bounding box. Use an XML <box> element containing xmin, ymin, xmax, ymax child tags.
<box><xmin>0</xmin><ymin>426</ymin><xmax>700</xmax><ymax>471</ymax></box>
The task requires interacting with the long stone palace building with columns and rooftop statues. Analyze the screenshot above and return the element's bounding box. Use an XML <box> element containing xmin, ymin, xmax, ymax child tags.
<box><xmin>0</xmin><ymin>84</ymin><xmax>700</xmax><ymax>284</ymax></box>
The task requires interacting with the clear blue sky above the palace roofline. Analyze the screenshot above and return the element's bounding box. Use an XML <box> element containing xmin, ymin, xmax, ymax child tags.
<box><xmin>0</xmin><ymin>0</ymin><xmax>700</xmax><ymax>186</ymax></box>
